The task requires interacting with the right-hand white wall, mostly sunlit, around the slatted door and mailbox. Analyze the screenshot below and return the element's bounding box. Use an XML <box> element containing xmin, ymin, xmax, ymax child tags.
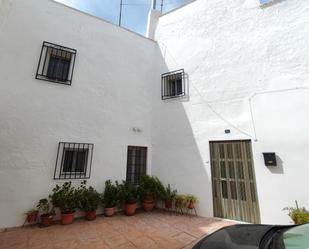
<box><xmin>152</xmin><ymin>0</ymin><xmax>309</xmax><ymax>226</ymax></box>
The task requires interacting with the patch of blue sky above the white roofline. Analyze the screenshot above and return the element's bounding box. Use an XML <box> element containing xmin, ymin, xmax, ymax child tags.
<box><xmin>56</xmin><ymin>0</ymin><xmax>190</xmax><ymax>34</ymax></box>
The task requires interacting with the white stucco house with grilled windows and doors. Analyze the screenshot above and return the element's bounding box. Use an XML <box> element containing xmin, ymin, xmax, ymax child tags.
<box><xmin>0</xmin><ymin>0</ymin><xmax>309</xmax><ymax>228</ymax></box>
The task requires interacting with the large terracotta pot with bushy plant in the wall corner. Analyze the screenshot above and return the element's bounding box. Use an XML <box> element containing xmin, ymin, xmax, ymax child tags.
<box><xmin>139</xmin><ymin>175</ymin><xmax>164</xmax><ymax>211</ymax></box>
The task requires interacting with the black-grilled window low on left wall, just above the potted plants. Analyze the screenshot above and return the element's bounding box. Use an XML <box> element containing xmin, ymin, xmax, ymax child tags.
<box><xmin>54</xmin><ymin>142</ymin><xmax>93</xmax><ymax>179</ymax></box>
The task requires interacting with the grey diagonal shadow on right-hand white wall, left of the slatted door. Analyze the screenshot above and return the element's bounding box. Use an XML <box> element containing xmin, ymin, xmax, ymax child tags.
<box><xmin>152</xmin><ymin>52</ymin><xmax>213</xmax><ymax>216</ymax></box>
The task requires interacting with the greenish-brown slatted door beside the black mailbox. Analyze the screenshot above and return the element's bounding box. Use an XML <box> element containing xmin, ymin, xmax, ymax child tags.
<box><xmin>210</xmin><ymin>140</ymin><xmax>260</xmax><ymax>223</ymax></box>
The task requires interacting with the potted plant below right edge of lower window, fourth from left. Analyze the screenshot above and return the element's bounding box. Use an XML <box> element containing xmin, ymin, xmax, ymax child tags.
<box><xmin>76</xmin><ymin>181</ymin><xmax>101</xmax><ymax>221</ymax></box>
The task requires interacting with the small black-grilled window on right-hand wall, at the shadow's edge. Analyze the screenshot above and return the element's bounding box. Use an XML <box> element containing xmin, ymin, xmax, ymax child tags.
<box><xmin>161</xmin><ymin>69</ymin><xmax>186</xmax><ymax>99</ymax></box>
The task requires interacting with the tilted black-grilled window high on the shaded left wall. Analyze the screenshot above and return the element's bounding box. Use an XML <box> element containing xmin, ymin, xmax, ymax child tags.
<box><xmin>35</xmin><ymin>41</ymin><xmax>76</xmax><ymax>85</ymax></box>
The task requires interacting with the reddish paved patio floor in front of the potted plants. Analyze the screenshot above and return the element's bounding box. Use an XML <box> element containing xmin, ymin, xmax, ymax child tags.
<box><xmin>0</xmin><ymin>211</ymin><xmax>233</xmax><ymax>249</ymax></box>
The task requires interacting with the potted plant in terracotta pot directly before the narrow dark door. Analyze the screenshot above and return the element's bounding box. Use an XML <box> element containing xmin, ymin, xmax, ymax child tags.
<box><xmin>116</xmin><ymin>181</ymin><xmax>139</xmax><ymax>216</ymax></box>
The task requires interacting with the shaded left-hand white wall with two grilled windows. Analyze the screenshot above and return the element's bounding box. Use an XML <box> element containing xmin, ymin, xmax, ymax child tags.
<box><xmin>0</xmin><ymin>0</ymin><xmax>164</xmax><ymax>227</ymax></box>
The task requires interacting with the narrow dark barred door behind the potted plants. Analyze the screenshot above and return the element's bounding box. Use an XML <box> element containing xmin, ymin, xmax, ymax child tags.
<box><xmin>126</xmin><ymin>146</ymin><xmax>147</xmax><ymax>185</ymax></box>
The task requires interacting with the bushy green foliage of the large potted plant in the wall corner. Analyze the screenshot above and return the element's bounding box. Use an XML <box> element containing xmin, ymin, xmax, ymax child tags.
<box><xmin>138</xmin><ymin>175</ymin><xmax>164</xmax><ymax>199</ymax></box>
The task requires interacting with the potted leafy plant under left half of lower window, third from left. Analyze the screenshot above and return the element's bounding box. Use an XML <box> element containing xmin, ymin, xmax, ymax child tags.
<box><xmin>50</xmin><ymin>182</ymin><xmax>77</xmax><ymax>225</ymax></box>
